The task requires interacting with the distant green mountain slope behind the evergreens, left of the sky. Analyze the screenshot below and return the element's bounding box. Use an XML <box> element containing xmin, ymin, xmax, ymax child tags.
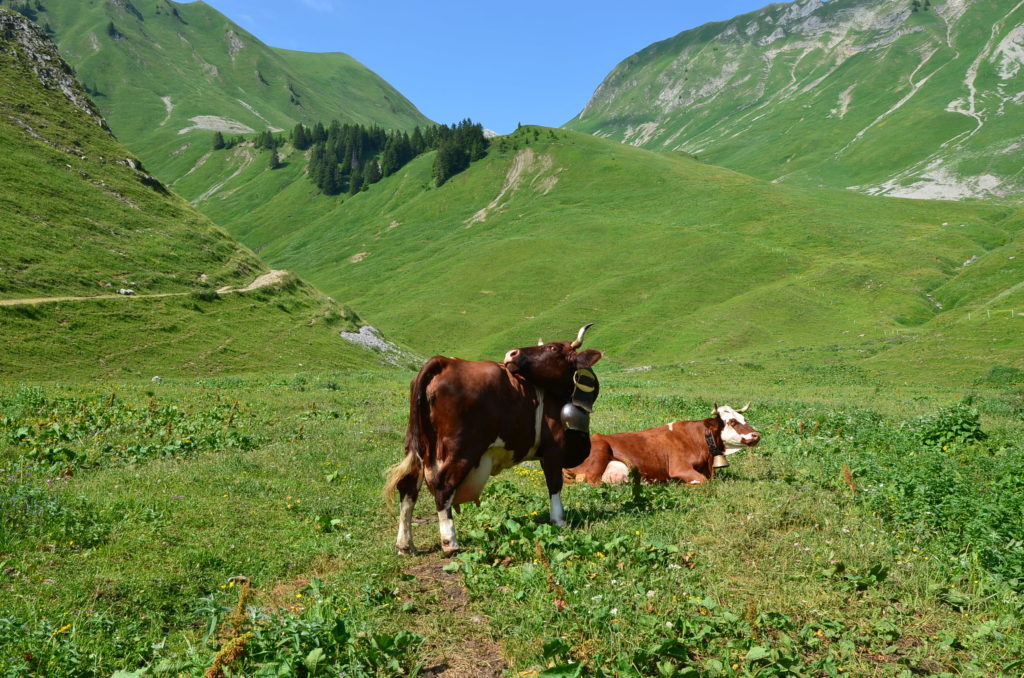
<box><xmin>4</xmin><ymin>0</ymin><xmax>429</xmax><ymax>182</ymax></box>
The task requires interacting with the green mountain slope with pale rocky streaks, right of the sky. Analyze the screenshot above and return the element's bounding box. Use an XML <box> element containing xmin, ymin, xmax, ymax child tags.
<box><xmin>566</xmin><ymin>0</ymin><xmax>1024</xmax><ymax>199</ymax></box>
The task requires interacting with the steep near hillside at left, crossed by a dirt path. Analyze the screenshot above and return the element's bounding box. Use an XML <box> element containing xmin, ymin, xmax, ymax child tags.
<box><xmin>0</xmin><ymin>8</ymin><xmax>373</xmax><ymax>378</ymax></box>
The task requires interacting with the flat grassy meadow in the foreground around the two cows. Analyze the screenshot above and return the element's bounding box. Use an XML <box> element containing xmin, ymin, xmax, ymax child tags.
<box><xmin>0</xmin><ymin>358</ymin><xmax>1024</xmax><ymax>677</ymax></box>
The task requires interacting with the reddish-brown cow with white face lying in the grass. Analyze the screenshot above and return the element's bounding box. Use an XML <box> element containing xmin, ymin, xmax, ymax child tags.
<box><xmin>565</xmin><ymin>404</ymin><xmax>761</xmax><ymax>485</ymax></box>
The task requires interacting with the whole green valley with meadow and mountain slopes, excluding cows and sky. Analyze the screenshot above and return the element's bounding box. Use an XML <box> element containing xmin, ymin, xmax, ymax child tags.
<box><xmin>0</xmin><ymin>0</ymin><xmax>1024</xmax><ymax>678</ymax></box>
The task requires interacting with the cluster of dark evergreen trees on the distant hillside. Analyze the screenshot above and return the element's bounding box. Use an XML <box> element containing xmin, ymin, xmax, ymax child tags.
<box><xmin>292</xmin><ymin>119</ymin><xmax>487</xmax><ymax>196</ymax></box>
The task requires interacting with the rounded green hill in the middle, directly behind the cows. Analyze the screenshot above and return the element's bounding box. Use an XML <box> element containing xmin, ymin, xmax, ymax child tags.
<box><xmin>211</xmin><ymin>128</ymin><xmax>1024</xmax><ymax>385</ymax></box>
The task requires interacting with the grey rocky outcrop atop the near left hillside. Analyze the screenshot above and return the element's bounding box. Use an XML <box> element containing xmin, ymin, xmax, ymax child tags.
<box><xmin>0</xmin><ymin>7</ymin><xmax>106</xmax><ymax>129</ymax></box>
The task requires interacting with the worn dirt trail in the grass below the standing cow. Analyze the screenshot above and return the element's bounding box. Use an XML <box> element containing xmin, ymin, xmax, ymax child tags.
<box><xmin>401</xmin><ymin>554</ymin><xmax>509</xmax><ymax>678</ymax></box>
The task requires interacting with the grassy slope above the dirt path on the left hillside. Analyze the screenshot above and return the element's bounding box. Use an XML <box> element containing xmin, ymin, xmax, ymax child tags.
<box><xmin>0</xmin><ymin>17</ymin><xmax>260</xmax><ymax>298</ymax></box>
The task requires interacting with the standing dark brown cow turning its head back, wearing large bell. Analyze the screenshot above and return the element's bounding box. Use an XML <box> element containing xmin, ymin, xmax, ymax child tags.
<box><xmin>384</xmin><ymin>325</ymin><xmax>601</xmax><ymax>553</ymax></box>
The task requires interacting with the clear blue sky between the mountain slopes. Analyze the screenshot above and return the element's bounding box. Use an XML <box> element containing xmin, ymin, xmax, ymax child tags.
<box><xmin>199</xmin><ymin>0</ymin><xmax>768</xmax><ymax>134</ymax></box>
